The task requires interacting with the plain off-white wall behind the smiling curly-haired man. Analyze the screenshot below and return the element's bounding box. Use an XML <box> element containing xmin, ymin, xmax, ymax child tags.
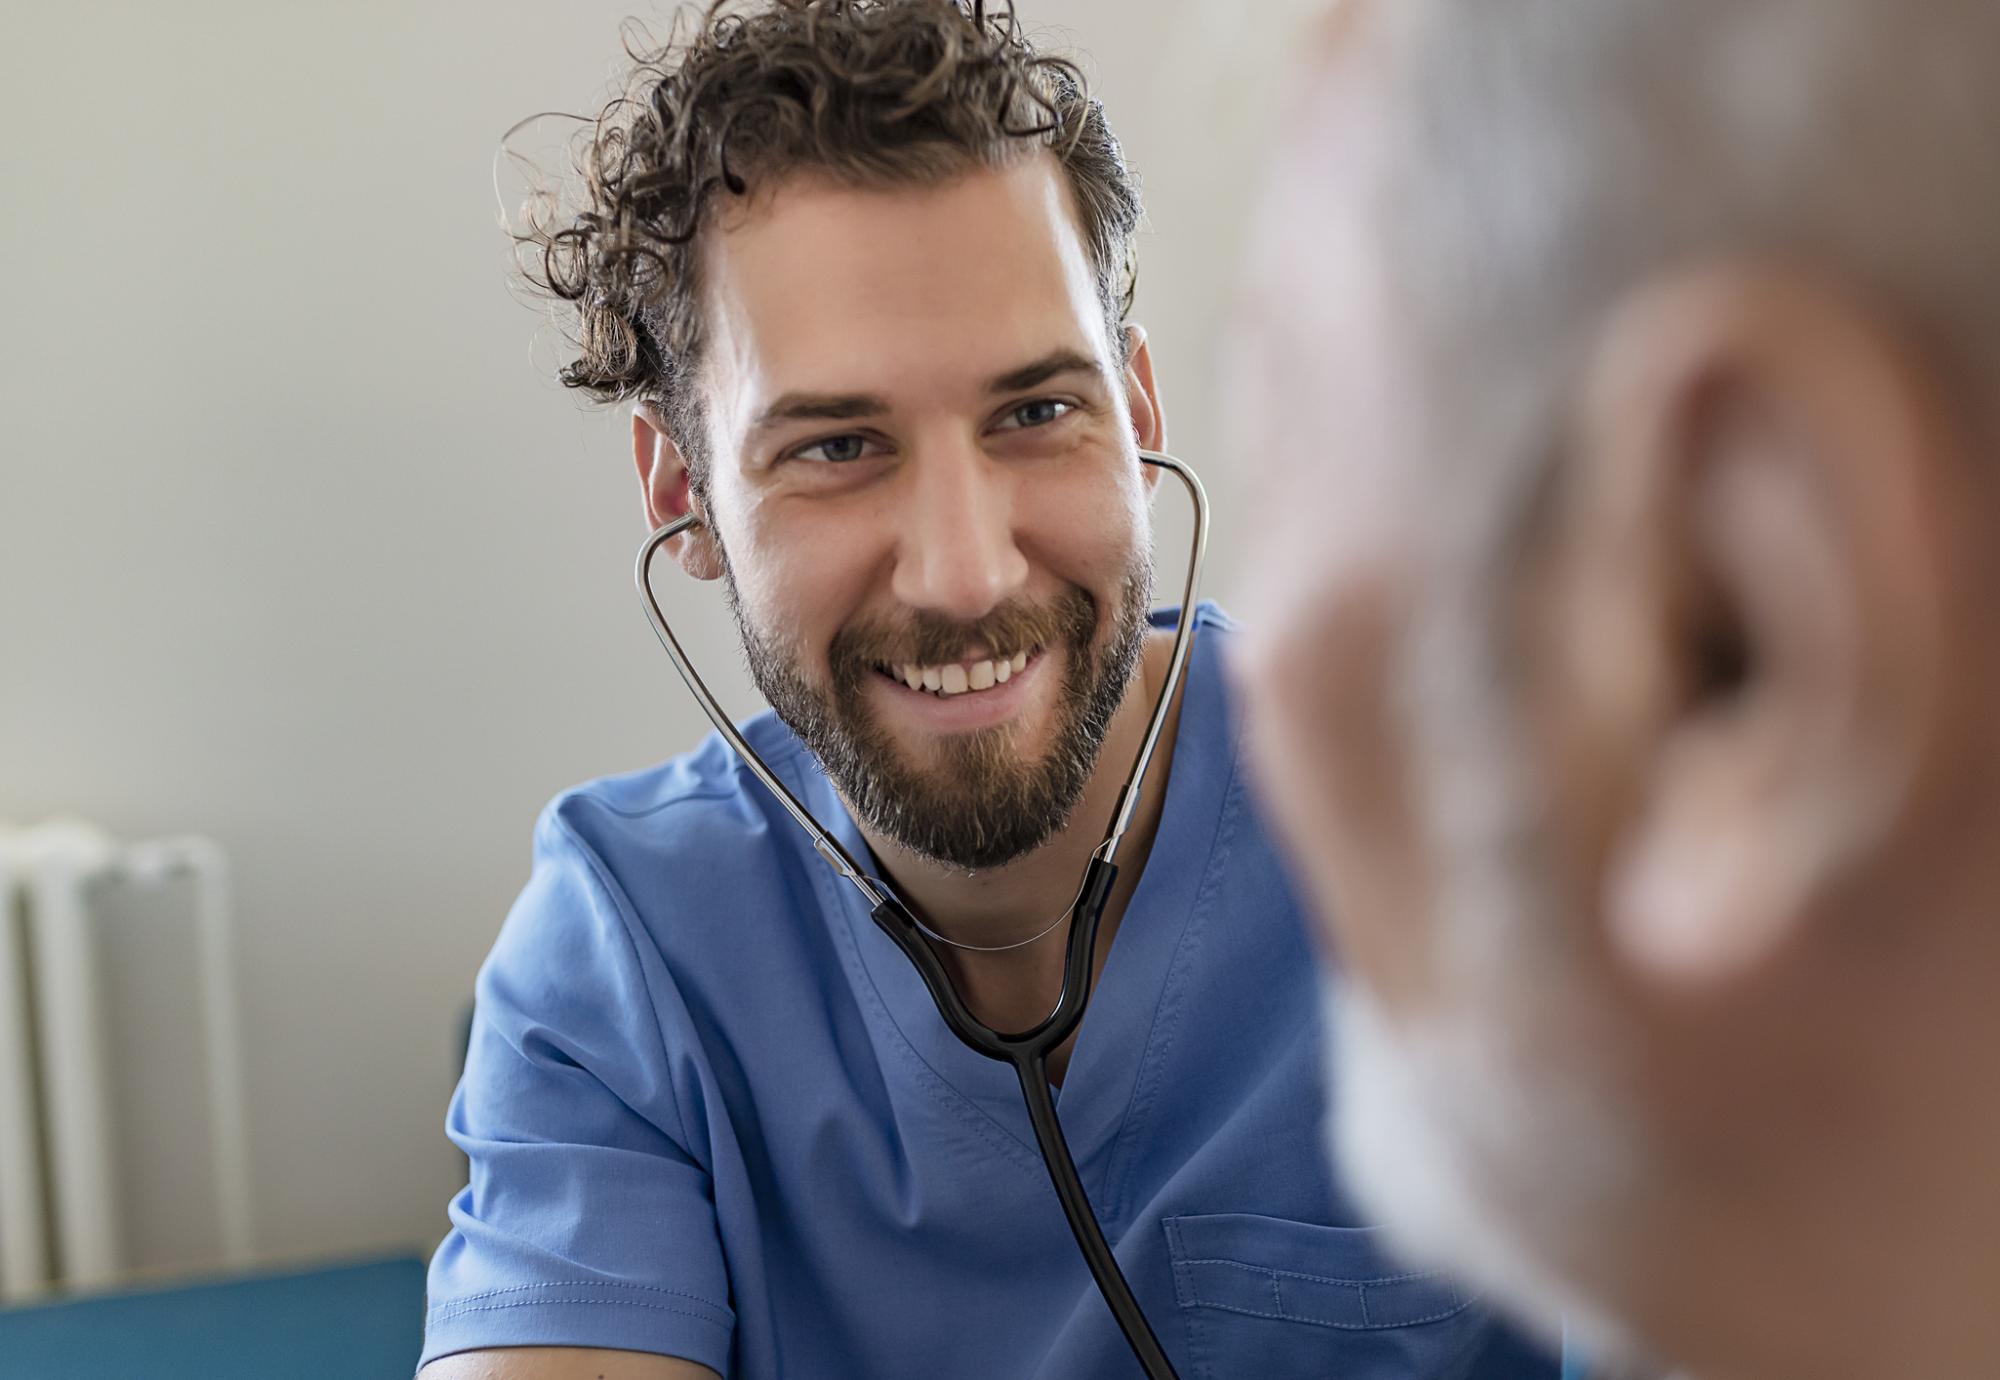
<box><xmin>0</xmin><ymin>0</ymin><xmax>1312</xmax><ymax>1258</ymax></box>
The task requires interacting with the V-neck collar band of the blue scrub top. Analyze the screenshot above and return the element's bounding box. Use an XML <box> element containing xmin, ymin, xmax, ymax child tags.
<box><xmin>788</xmin><ymin>604</ymin><xmax>1236</xmax><ymax>1184</ymax></box>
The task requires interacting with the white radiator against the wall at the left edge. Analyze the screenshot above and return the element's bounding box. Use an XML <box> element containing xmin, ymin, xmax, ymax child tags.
<box><xmin>0</xmin><ymin>824</ymin><xmax>252</xmax><ymax>1302</ymax></box>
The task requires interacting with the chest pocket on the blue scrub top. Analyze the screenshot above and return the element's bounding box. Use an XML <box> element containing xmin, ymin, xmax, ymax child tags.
<box><xmin>1160</xmin><ymin>1212</ymin><xmax>1482</xmax><ymax>1380</ymax></box>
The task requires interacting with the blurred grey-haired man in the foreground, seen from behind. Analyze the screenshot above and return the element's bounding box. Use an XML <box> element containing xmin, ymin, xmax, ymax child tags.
<box><xmin>1236</xmin><ymin>0</ymin><xmax>2000</xmax><ymax>1380</ymax></box>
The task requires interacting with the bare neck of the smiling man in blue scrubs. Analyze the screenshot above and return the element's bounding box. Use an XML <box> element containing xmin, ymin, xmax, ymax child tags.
<box><xmin>862</xmin><ymin>632</ymin><xmax>1180</xmax><ymax>1056</ymax></box>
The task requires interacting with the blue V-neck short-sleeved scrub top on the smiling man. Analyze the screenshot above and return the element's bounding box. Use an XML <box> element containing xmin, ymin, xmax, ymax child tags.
<box><xmin>424</xmin><ymin>606</ymin><xmax>1558</xmax><ymax>1380</ymax></box>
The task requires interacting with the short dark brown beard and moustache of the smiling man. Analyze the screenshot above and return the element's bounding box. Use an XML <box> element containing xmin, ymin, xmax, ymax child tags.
<box><xmin>724</xmin><ymin>552</ymin><xmax>1152</xmax><ymax>870</ymax></box>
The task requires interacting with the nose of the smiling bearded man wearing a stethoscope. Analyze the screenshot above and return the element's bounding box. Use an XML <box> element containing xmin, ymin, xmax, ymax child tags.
<box><xmin>892</xmin><ymin>446</ymin><xmax>1028</xmax><ymax>622</ymax></box>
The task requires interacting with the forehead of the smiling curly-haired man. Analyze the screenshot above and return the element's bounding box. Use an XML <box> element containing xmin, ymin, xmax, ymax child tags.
<box><xmin>702</xmin><ymin>154</ymin><xmax>1106</xmax><ymax>406</ymax></box>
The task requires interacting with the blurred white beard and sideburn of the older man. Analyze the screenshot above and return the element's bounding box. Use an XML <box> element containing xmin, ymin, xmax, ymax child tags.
<box><xmin>1322</xmin><ymin>580</ymin><xmax>1652</xmax><ymax>1374</ymax></box>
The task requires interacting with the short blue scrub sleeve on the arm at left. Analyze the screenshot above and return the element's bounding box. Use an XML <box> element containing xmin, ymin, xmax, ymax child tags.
<box><xmin>422</xmin><ymin>802</ymin><xmax>734</xmax><ymax>1372</ymax></box>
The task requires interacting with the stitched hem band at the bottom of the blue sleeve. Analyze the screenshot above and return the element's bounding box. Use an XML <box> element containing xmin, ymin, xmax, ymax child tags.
<box><xmin>418</xmin><ymin>1288</ymin><xmax>734</xmax><ymax>1374</ymax></box>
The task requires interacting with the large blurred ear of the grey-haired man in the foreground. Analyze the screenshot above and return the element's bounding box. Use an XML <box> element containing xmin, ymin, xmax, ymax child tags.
<box><xmin>1550</xmin><ymin>266</ymin><xmax>1970</xmax><ymax>986</ymax></box>
